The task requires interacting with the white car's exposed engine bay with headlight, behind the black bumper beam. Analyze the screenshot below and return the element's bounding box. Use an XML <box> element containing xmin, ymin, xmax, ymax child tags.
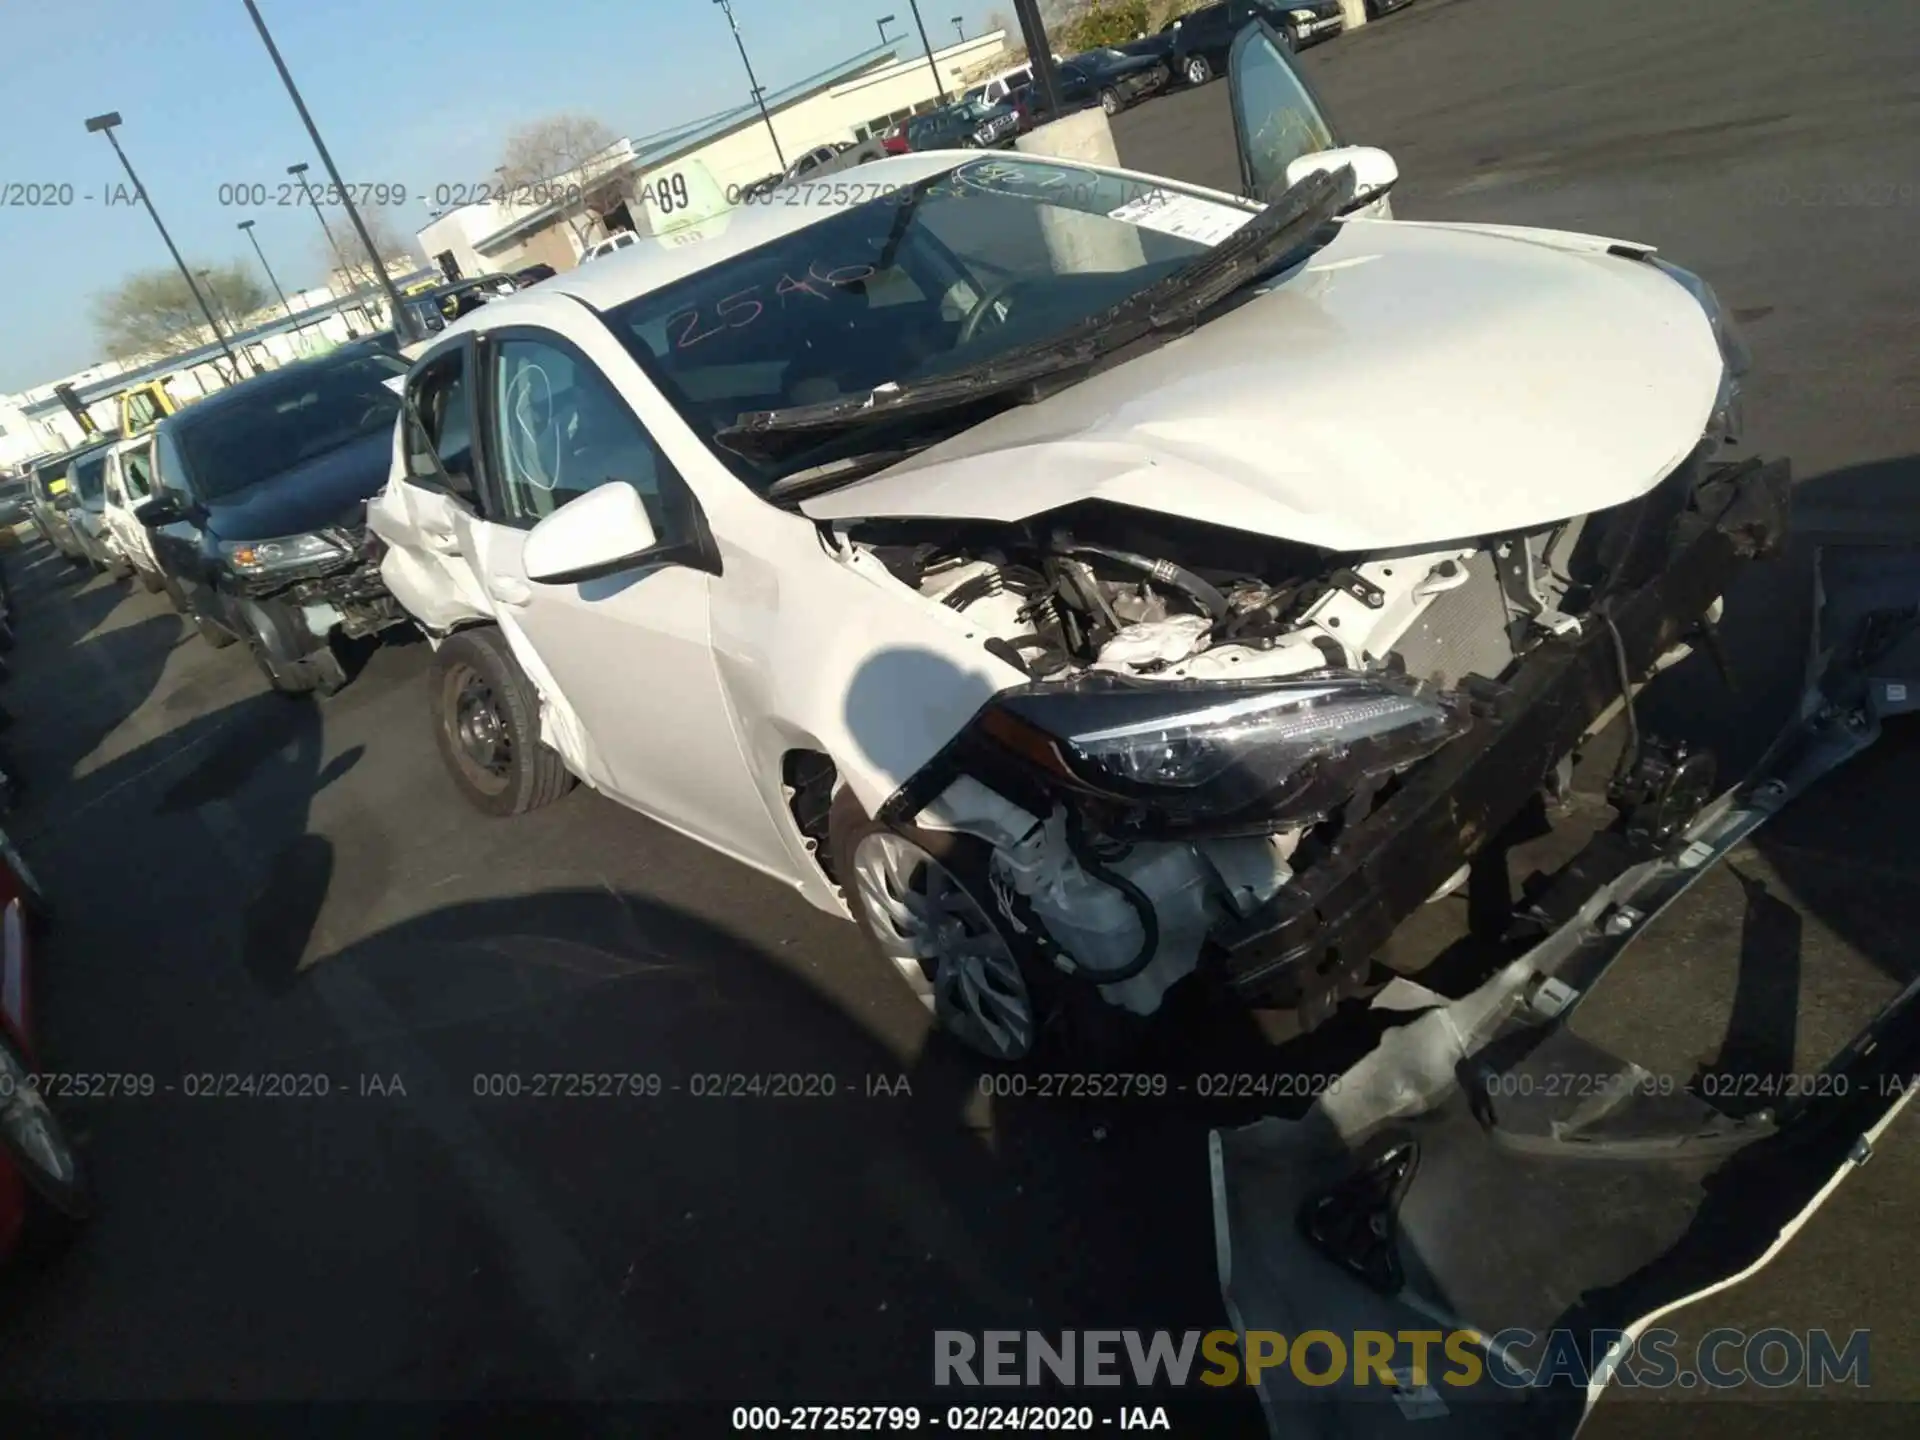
<box><xmin>849</xmin><ymin>470</ymin><xmax>1758</xmax><ymax>1014</ymax></box>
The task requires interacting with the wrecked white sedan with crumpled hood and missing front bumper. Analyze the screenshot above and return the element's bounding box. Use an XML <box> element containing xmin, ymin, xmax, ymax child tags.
<box><xmin>371</xmin><ymin>27</ymin><xmax>1786</xmax><ymax>1060</ymax></box>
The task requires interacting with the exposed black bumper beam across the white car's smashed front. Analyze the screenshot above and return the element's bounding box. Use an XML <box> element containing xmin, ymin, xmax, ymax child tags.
<box><xmin>1212</xmin><ymin>461</ymin><xmax>1789</xmax><ymax>1020</ymax></box>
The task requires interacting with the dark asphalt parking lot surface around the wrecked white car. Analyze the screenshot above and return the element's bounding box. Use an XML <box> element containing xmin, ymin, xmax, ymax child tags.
<box><xmin>0</xmin><ymin>0</ymin><xmax>1920</xmax><ymax>1436</ymax></box>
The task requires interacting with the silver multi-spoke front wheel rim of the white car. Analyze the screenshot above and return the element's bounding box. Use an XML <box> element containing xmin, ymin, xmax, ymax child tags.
<box><xmin>852</xmin><ymin>831</ymin><xmax>1035</xmax><ymax>1060</ymax></box>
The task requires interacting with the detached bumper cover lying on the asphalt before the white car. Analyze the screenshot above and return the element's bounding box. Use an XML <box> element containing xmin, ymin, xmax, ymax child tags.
<box><xmin>1212</xmin><ymin>547</ymin><xmax>1920</xmax><ymax>1438</ymax></box>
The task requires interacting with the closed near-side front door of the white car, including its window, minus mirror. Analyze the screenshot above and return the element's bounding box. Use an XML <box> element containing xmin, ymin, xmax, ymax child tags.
<box><xmin>467</xmin><ymin>324</ymin><xmax>791</xmax><ymax>872</ymax></box>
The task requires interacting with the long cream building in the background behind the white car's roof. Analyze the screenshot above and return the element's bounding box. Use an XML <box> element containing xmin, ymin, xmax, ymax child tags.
<box><xmin>417</xmin><ymin>31</ymin><xmax>1008</xmax><ymax>275</ymax></box>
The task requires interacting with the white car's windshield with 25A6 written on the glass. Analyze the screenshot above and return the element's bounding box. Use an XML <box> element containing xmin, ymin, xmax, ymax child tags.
<box><xmin>609</xmin><ymin>156</ymin><xmax>1252</xmax><ymax>490</ymax></box>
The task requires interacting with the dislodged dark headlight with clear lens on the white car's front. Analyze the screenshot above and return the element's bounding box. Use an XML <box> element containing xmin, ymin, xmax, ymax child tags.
<box><xmin>981</xmin><ymin>670</ymin><xmax>1469</xmax><ymax>822</ymax></box>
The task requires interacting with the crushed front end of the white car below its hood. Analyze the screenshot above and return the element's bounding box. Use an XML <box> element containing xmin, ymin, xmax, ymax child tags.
<box><xmin>852</xmin><ymin>440</ymin><xmax>1789</xmax><ymax>1025</ymax></box>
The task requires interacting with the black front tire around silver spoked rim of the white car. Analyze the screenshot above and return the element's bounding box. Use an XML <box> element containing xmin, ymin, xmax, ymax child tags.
<box><xmin>828</xmin><ymin>789</ymin><xmax>1150</xmax><ymax>1066</ymax></box>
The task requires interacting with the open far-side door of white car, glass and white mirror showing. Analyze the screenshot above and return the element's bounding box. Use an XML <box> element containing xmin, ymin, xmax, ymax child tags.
<box><xmin>1227</xmin><ymin>19</ymin><xmax>1398</xmax><ymax>219</ymax></box>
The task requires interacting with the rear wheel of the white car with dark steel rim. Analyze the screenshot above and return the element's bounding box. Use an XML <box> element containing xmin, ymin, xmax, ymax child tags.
<box><xmin>428</xmin><ymin>626</ymin><xmax>574</xmax><ymax>816</ymax></box>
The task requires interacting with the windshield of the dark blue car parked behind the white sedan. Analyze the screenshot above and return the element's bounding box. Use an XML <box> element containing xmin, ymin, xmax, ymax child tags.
<box><xmin>167</xmin><ymin>353</ymin><xmax>407</xmax><ymax>499</ymax></box>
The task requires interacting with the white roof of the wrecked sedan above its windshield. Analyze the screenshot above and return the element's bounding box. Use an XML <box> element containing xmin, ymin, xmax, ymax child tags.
<box><xmin>541</xmin><ymin>150</ymin><xmax>981</xmax><ymax>309</ymax></box>
